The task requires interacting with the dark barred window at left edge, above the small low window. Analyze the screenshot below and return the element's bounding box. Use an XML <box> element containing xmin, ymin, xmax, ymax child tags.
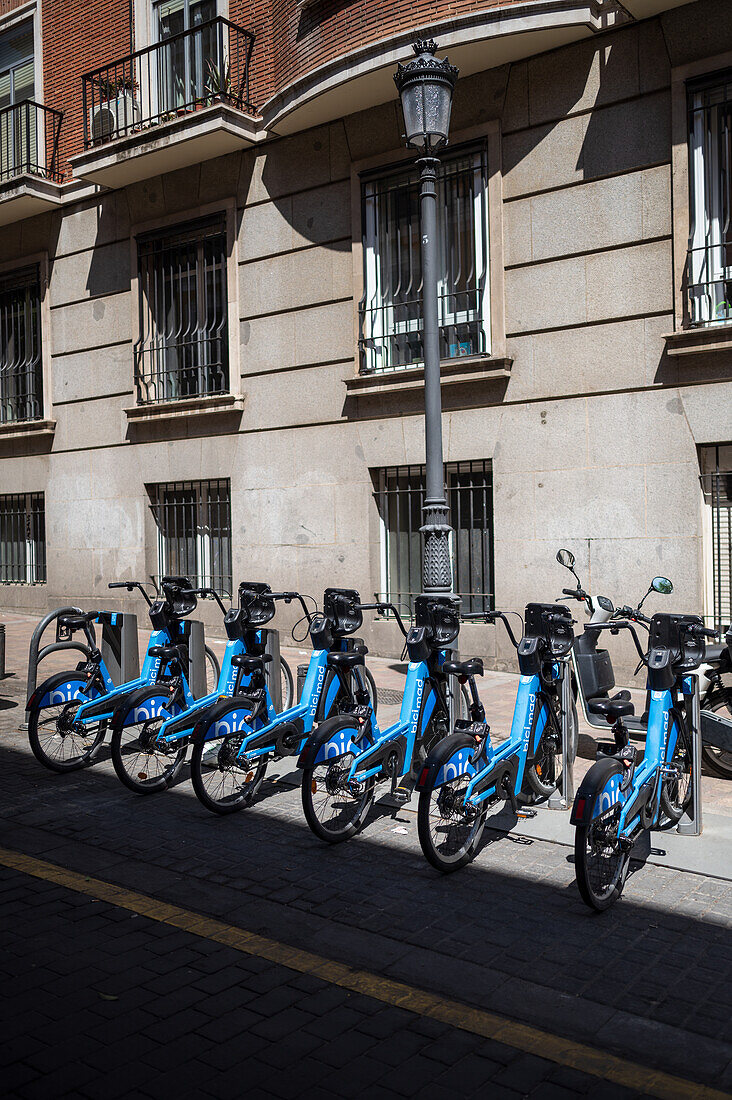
<box><xmin>0</xmin><ymin>264</ymin><xmax>43</xmax><ymax>424</ymax></box>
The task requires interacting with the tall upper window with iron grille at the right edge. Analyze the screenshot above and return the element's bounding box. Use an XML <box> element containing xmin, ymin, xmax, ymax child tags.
<box><xmin>687</xmin><ymin>72</ymin><xmax>732</xmax><ymax>325</ymax></box>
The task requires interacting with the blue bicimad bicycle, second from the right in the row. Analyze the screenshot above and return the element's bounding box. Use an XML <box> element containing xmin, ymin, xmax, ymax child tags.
<box><xmin>417</xmin><ymin>604</ymin><xmax>577</xmax><ymax>872</ymax></box>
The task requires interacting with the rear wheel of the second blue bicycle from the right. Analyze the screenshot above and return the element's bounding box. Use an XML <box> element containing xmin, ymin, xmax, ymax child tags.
<box><xmin>417</xmin><ymin>774</ymin><xmax>488</xmax><ymax>875</ymax></box>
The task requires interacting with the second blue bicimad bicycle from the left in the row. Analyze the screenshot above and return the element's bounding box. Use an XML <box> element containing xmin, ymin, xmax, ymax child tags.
<box><xmin>106</xmin><ymin>581</ymin><xmax>292</xmax><ymax>794</ymax></box>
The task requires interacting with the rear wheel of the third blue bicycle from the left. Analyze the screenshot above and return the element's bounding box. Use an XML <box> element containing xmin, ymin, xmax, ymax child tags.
<box><xmin>190</xmin><ymin>734</ymin><xmax>267</xmax><ymax>814</ymax></box>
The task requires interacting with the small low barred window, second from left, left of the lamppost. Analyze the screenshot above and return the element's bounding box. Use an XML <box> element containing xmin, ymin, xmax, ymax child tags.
<box><xmin>148</xmin><ymin>479</ymin><xmax>231</xmax><ymax>593</ymax></box>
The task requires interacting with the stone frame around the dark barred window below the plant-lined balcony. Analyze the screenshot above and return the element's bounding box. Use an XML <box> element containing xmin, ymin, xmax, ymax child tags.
<box><xmin>130</xmin><ymin>198</ymin><xmax>236</xmax><ymax>416</ymax></box>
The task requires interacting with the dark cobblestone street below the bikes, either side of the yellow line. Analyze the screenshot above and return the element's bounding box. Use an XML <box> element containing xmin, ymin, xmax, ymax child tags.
<box><xmin>0</xmin><ymin>618</ymin><xmax>732</xmax><ymax>1100</ymax></box>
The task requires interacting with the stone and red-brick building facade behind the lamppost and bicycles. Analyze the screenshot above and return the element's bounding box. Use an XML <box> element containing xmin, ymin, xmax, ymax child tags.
<box><xmin>0</xmin><ymin>0</ymin><xmax>732</xmax><ymax>668</ymax></box>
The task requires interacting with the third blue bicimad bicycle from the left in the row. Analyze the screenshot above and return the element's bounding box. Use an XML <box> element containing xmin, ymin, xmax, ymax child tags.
<box><xmin>190</xmin><ymin>589</ymin><xmax>376</xmax><ymax>814</ymax></box>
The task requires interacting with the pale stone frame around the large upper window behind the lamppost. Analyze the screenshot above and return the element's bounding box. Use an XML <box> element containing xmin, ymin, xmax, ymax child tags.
<box><xmin>351</xmin><ymin>119</ymin><xmax>506</xmax><ymax>381</ymax></box>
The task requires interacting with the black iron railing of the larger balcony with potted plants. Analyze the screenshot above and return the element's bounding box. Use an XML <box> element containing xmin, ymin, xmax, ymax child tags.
<box><xmin>81</xmin><ymin>18</ymin><xmax>254</xmax><ymax>149</ymax></box>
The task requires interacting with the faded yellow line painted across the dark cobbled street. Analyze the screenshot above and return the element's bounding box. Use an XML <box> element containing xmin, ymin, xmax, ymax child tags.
<box><xmin>0</xmin><ymin>848</ymin><xmax>730</xmax><ymax>1100</ymax></box>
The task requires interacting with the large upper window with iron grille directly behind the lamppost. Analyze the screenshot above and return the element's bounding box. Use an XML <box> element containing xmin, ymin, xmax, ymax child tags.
<box><xmin>359</xmin><ymin>149</ymin><xmax>491</xmax><ymax>374</ymax></box>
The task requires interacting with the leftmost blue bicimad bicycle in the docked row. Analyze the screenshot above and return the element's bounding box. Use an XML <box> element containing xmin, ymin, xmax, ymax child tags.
<box><xmin>26</xmin><ymin>576</ymin><xmax>212</xmax><ymax>772</ymax></box>
